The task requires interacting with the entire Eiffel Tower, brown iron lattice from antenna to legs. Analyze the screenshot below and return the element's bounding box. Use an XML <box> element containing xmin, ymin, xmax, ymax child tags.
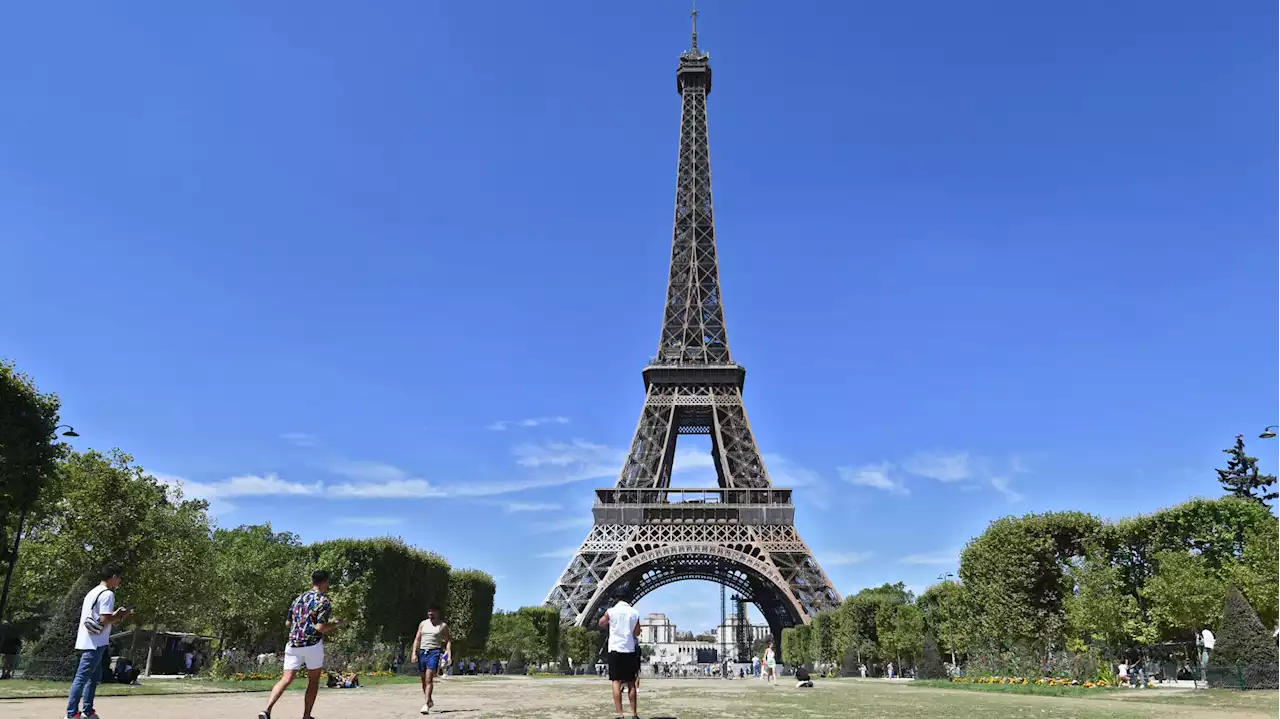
<box><xmin>547</xmin><ymin>10</ymin><xmax>840</xmax><ymax>637</ymax></box>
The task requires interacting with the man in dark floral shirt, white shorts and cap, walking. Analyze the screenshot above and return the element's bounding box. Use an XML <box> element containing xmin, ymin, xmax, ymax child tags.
<box><xmin>257</xmin><ymin>569</ymin><xmax>346</xmax><ymax>719</ymax></box>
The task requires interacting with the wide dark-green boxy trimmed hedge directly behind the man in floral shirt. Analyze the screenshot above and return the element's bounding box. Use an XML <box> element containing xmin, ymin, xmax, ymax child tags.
<box><xmin>308</xmin><ymin>537</ymin><xmax>449</xmax><ymax>649</ymax></box>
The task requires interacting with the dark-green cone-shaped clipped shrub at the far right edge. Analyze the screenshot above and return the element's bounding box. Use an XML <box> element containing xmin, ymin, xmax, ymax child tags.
<box><xmin>1210</xmin><ymin>587</ymin><xmax>1280</xmax><ymax>688</ymax></box>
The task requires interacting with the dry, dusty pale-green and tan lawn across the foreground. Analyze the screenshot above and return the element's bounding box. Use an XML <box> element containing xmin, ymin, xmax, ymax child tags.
<box><xmin>0</xmin><ymin>677</ymin><xmax>1280</xmax><ymax>719</ymax></box>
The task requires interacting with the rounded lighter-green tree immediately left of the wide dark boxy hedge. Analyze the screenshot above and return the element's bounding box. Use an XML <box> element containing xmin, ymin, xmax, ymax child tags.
<box><xmin>211</xmin><ymin>523</ymin><xmax>310</xmax><ymax>651</ymax></box>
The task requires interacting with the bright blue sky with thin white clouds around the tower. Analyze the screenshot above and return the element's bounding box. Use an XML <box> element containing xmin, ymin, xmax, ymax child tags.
<box><xmin>0</xmin><ymin>0</ymin><xmax>1280</xmax><ymax>628</ymax></box>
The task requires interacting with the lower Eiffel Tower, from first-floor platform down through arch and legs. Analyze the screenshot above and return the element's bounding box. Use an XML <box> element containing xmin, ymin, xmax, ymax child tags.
<box><xmin>547</xmin><ymin>489</ymin><xmax>840</xmax><ymax>640</ymax></box>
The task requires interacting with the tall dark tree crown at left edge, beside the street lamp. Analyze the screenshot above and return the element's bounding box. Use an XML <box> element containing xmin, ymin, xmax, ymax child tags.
<box><xmin>0</xmin><ymin>360</ymin><xmax>65</xmax><ymax>563</ymax></box>
